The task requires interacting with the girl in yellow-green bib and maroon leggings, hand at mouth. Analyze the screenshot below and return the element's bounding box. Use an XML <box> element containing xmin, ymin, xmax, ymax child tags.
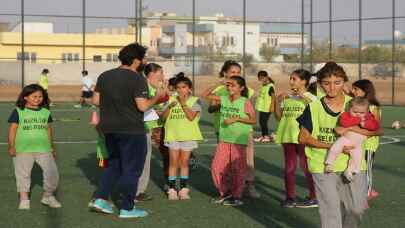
<box><xmin>274</xmin><ymin>69</ymin><xmax>318</xmax><ymax>208</ymax></box>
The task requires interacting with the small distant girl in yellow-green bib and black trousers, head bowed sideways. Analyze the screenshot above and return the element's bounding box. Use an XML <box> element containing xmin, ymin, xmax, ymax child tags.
<box><xmin>254</xmin><ymin>70</ymin><xmax>275</xmax><ymax>143</ymax></box>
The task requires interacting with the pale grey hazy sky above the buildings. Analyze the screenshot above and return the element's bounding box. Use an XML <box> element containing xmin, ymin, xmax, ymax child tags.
<box><xmin>0</xmin><ymin>0</ymin><xmax>405</xmax><ymax>44</ymax></box>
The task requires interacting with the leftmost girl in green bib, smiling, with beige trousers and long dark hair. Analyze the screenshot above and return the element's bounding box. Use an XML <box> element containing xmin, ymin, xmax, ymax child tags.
<box><xmin>8</xmin><ymin>84</ymin><xmax>61</xmax><ymax>210</ymax></box>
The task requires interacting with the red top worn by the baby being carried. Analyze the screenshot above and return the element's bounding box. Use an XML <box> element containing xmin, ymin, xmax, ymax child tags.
<box><xmin>339</xmin><ymin>112</ymin><xmax>380</xmax><ymax>131</ymax></box>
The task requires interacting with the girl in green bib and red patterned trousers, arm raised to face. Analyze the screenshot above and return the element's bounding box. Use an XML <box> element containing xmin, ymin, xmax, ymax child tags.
<box><xmin>203</xmin><ymin>76</ymin><xmax>256</xmax><ymax>206</ymax></box>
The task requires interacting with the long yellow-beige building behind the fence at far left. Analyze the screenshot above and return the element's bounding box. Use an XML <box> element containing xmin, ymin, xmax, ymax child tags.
<box><xmin>0</xmin><ymin>22</ymin><xmax>161</xmax><ymax>63</ymax></box>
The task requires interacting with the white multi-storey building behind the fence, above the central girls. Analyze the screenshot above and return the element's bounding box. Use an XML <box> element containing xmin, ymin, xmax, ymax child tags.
<box><xmin>159</xmin><ymin>23</ymin><xmax>260</xmax><ymax>59</ymax></box>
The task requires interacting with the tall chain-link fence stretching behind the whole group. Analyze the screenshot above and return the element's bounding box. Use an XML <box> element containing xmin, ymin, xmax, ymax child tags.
<box><xmin>0</xmin><ymin>0</ymin><xmax>405</xmax><ymax>105</ymax></box>
